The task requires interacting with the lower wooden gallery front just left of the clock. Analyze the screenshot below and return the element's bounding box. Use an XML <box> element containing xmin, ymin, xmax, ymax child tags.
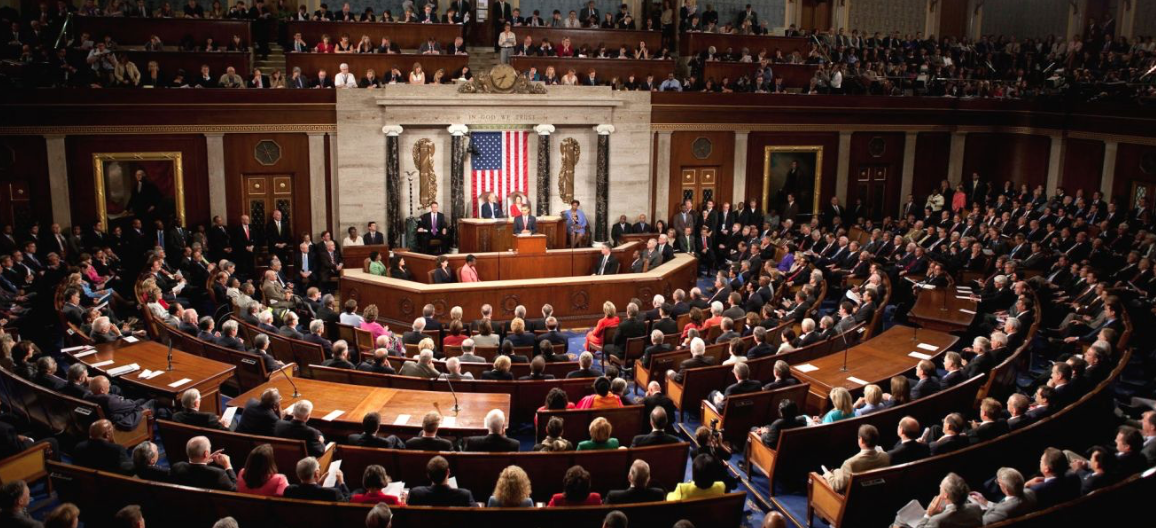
<box><xmin>286</xmin><ymin>53</ymin><xmax>469</xmax><ymax>77</ymax></box>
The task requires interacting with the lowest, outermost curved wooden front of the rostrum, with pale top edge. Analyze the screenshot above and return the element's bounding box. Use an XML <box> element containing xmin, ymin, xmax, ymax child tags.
<box><xmin>340</xmin><ymin>254</ymin><xmax>698</xmax><ymax>324</ymax></box>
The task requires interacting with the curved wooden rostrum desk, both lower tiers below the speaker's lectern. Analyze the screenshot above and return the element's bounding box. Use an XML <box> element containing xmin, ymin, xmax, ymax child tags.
<box><xmin>340</xmin><ymin>246</ymin><xmax>698</xmax><ymax>326</ymax></box>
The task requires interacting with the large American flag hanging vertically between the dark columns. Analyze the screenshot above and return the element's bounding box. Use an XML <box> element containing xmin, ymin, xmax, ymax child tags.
<box><xmin>470</xmin><ymin>131</ymin><xmax>529</xmax><ymax>216</ymax></box>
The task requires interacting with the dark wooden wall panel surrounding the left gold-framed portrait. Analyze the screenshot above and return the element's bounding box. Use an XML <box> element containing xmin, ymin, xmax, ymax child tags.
<box><xmin>65</xmin><ymin>135</ymin><xmax>209</xmax><ymax>229</ymax></box>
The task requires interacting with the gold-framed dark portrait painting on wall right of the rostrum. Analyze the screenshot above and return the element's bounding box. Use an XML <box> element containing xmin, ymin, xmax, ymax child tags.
<box><xmin>763</xmin><ymin>146</ymin><xmax>823</xmax><ymax>217</ymax></box>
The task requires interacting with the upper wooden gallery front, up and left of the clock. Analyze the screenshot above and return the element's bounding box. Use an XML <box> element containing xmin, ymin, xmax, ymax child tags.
<box><xmin>286</xmin><ymin>22</ymin><xmax>461</xmax><ymax>50</ymax></box>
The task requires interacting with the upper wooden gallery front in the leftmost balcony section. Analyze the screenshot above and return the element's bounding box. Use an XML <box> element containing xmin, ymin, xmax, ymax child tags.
<box><xmin>72</xmin><ymin>16</ymin><xmax>253</xmax><ymax>46</ymax></box>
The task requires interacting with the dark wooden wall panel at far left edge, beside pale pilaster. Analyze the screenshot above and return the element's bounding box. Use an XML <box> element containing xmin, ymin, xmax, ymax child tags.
<box><xmin>0</xmin><ymin>135</ymin><xmax>52</xmax><ymax>227</ymax></box>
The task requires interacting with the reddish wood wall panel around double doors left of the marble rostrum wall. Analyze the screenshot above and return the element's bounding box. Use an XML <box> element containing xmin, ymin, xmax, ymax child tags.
<box><xmin>224</xmin><ymin>134</ymin><xmax>309</xmax><ymax>236</ymax></box>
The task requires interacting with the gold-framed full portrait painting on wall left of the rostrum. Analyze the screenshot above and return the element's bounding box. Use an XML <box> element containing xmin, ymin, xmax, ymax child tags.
<box><xmin>92</xmin><ymin>153</ymin><xmax>185</xmax><ymax>231</ymax></box>
